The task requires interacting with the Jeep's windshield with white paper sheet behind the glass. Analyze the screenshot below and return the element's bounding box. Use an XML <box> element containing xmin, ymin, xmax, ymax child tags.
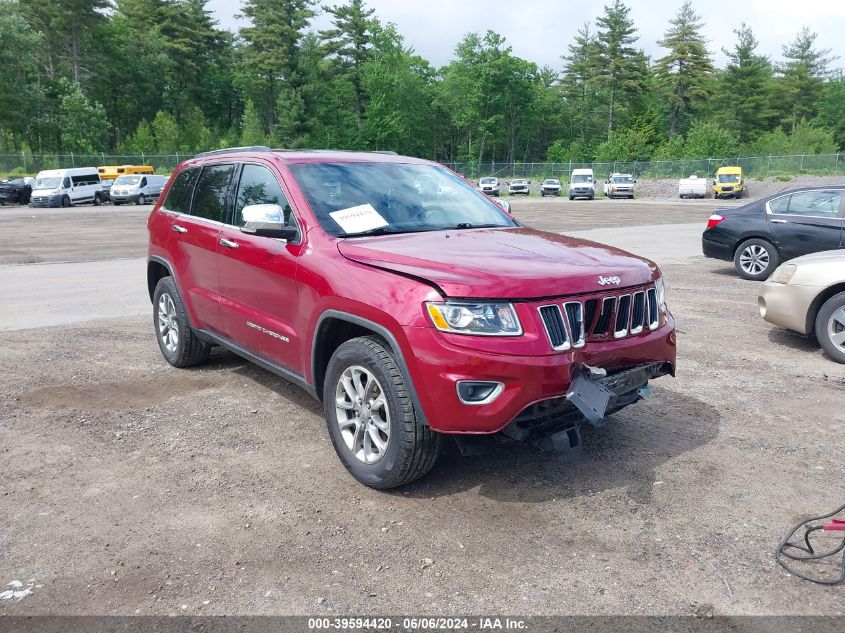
<box><xmin>290</xmin><ymin>163</ymin><xmax>516</xmax><ymax>236</ymax></box>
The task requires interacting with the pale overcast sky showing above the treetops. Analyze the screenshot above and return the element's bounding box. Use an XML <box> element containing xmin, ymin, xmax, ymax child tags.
<box><xmin>209</xmin><ymin>0</ymin><xmax>845</xmax><ymax>69</ymax></box>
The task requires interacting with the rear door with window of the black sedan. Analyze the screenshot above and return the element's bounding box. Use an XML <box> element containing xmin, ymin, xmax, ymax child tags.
<box><xmin>767</xmin><ymin>188</ymin><xmax>845</xmax><ymax>259</ymax></box>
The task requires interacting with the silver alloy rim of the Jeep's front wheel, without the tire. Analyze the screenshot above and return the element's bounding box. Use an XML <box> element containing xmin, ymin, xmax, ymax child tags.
<box><xmin>335</xmin><ymin>365</ymin><xmax>390</xmax><ymax>464</ymax></box>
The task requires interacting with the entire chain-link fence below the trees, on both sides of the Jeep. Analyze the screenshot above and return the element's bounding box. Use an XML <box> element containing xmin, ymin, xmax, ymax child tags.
<box><xmin>0</xmin><ymin>153</ymin><xmax>845</xmax><ymax>181</ymax></box>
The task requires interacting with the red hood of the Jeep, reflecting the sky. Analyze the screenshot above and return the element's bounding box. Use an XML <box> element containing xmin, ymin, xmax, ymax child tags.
<box><xmin>338</xmin><ymin>228</ymin><xmax>658</xmax><ymax>299</ymax></box>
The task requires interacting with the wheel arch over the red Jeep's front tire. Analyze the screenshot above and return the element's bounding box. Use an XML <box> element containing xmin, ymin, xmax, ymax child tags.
<box><xmin>311</xmin><ymin>310</ymin><xmax>428</xmax><ymax>426</ymax></box>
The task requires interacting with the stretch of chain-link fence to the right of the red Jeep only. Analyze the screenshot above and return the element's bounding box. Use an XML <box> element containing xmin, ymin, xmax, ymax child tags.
<box><xmin>447</xmin><ymin>153</ymin><xmax>845</xmax><ymax>181</ymax></box>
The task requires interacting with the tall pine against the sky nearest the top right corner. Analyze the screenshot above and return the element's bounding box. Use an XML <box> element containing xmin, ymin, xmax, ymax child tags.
<box><xmin>777</xmin><ymin>26</ymin><xmax>834</xmax><ymax>130</ymax></box>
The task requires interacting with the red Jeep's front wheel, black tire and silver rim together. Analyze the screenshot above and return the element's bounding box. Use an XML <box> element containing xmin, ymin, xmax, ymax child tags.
<box><xmin>323</xmin><ymin>336</ymin><xmax>441</xmax><ymax>490</ymax></box>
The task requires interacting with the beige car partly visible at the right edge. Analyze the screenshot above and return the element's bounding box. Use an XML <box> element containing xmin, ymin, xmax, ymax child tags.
<box><xmin>757</xmin><ymin>249</ymin><xmax>845</xmax><ymax>363</ymax></box>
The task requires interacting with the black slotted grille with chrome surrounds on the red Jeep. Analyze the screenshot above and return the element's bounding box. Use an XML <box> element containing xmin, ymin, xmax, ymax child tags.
<box><xmin>538</xmin><ymin>286</ymin><xmax>660</xmax><ymax>351</ymax></box>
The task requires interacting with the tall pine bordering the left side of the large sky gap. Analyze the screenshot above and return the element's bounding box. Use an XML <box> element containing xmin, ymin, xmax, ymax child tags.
<box><xmin>320</xmin><ymin>0</ymin><xmax>376</xmax><ymax>126</ymax></box>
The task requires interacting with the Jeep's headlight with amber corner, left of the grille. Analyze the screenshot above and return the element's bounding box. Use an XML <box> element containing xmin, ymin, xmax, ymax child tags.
<box><xmin>425</xmin><ymin>301</ymin><xmax>522</xmax><ymax>336</ymax></box>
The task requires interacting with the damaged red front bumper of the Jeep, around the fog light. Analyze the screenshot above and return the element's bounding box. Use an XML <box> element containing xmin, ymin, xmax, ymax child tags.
<box><xmin>405</xmin><ymin>316</ymin><xmax>676</xmax><ymax>433</ymax></box>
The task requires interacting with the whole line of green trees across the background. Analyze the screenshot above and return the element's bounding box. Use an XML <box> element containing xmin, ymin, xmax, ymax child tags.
<box><xmin>0</xmin><ymin>0</ymin><xmax>845</xmax><ymax>162</ymax></box>
